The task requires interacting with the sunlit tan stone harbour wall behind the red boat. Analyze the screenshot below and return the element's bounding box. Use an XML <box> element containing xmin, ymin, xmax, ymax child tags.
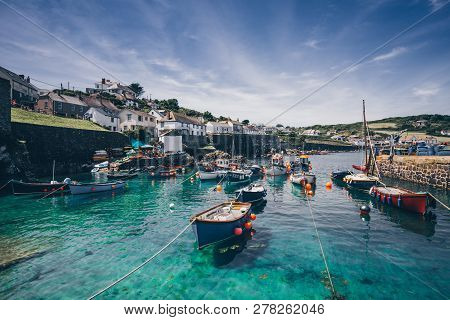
<box><xmin>377</xmin><ymin>156</ymin><xmax>450</xmax><ymax>190</ymax></box>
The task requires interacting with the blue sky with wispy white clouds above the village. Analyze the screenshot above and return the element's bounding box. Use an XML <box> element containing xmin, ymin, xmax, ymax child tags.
<box><xmin>0</xmin><ymin>0</ymin><xmax>450</xmax><ymax>126</ymax></box>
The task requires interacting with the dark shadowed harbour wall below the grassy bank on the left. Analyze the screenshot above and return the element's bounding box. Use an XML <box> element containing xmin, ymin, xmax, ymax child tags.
<box><xmin>0</xmin><ymin>122</ymin><xmax>130</xmax><ymax>180</ymax></box>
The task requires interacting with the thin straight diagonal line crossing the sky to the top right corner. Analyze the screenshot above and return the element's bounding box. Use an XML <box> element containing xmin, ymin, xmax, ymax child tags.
<box><xmin>266</xmin><ymin>0</ymin><xmax>450</xmax><ymax>126</ymax></box>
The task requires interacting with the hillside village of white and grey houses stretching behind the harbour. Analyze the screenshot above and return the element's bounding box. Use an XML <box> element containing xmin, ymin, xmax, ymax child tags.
<box><xmin>0</xmin><ymin>67</ymin><xmax>450</xmax><ymax>151</ymax></box>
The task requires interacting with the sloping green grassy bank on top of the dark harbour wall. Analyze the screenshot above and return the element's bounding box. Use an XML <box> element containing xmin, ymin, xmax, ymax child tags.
<box><xmin>11</xmin><ymin>108</ymin><xmax>108</xmax><ymax>131</ymax></box>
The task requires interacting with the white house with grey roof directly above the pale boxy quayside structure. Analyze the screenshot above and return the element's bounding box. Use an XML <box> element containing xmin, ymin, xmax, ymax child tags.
<box><xmin>158</xmin><ymin>111</ymin><xmax>206</xmax><ymax>136</ymax></box>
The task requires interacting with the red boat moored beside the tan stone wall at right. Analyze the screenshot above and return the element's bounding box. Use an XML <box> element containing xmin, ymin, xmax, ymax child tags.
<box><xmin>369</xmin><ymin>186</ymin><xmax>429</xmax><ymax>214</ymax></box>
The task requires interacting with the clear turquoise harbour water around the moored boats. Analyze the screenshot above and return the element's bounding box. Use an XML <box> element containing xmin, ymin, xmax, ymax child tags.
<box><xmin>0</xmin><ymin>153</ymin><xmax>450</xmax><ymax>299</ymax></box>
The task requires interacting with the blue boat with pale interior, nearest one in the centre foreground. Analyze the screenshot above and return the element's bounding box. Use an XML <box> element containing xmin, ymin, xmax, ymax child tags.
<box><xmin>190</xmin><ymin>202</ymin><xmax>251</xmax><ymax>249</ymax></box>
